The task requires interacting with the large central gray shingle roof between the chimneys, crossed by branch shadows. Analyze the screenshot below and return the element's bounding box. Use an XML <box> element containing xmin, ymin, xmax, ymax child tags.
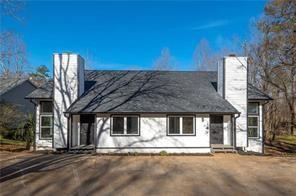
<box><xmin>67</xmin><ymin>71</ymin><xmax>237</xmax><ymax>113</ymax></box>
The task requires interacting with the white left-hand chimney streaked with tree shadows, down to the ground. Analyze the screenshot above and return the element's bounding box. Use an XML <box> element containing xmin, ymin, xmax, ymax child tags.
<box><xmin>53</xmin><ymin>53</ymin><xmax>84</xmax><ymax>148</ymax></box>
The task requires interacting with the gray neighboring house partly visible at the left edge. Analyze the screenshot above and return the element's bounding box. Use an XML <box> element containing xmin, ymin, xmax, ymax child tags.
<box><xmin>0</xmin><ymin>77</ymin><xmax>37</xmax><ymax>114</ymax></box>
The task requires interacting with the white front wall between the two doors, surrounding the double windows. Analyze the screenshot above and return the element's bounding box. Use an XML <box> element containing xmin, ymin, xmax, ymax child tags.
<box><xmin>96</xmin><ymin>114</ymin><xmax>211</xmax><ymax>153</ymax></box>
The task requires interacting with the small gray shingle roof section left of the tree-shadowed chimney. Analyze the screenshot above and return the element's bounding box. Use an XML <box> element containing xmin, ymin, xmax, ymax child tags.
<box><xmin>26</xmin><ymin>80</ymin><xmax>53</xmax><ymax>99</ymax></box>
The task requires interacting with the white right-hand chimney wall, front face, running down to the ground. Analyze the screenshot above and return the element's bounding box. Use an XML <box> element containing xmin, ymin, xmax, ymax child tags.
<box><xmin>224</xmin><ymin>57</ymin><xmax>248</xmax><ymax>148</ymax></box>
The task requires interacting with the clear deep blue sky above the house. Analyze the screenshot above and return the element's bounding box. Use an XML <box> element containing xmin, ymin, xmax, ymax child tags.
<box><xmin>1</xmin><ymin>0</ymin><xmax>266</xmax><ymax>74</ymax></box>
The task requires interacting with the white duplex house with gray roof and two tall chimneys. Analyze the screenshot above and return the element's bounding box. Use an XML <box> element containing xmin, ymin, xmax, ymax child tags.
<box><xmin>27</xmin><ymin>53</ymin><xmax>271</xmax><ymax>153</ymax></box>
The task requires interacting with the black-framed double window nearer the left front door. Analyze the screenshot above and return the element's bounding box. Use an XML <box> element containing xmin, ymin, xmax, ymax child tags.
<box><xmin>111</xmin><ymin>116</ymin><xmax>139</xmax><ymax>135</ymax></box>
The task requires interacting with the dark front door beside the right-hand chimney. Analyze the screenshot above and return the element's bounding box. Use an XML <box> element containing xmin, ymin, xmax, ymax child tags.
<box><xmin>210</xmin><ymin>115</ymin><xmax>223</xmax><ymax>144</ymax></box>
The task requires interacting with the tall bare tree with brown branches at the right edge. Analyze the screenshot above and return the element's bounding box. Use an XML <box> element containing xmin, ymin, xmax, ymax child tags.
<box><xmin>248</xmin><ymin>0</ymin><xmax>296</xmax><ymax>138</ymax></box>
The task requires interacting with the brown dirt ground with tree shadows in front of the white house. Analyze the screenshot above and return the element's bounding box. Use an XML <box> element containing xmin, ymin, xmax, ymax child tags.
<box><xmin>0</xmin><ymin>152</ymin><xmax>296</xmax><ymax>196</ymax></box>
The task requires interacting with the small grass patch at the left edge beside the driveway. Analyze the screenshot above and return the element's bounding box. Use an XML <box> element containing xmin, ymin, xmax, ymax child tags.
<box><xmin>0</xmin><ymin>136</ymin><xmax>26</xmax><ymax>152</ymax></box>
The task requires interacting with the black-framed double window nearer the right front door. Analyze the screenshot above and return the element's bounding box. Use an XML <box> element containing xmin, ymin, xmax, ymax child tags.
<box><xmin>168</xmin><ymin>116</ymin><xmax>195</xmax><ymax>135</ymax></box>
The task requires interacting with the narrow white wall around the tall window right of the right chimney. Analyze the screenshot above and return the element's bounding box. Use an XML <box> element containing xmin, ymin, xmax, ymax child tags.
<box><xmin>247</xmin><ymin>103</ymin><xmax>263</xmax><ymax>153</ymax></box>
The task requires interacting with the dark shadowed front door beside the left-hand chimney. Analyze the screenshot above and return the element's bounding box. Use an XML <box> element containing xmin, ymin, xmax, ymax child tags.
<box><xmin>80</xmin><ymin>114</ymin><xmax>95</xmax><ymax>145</ymax></box>
